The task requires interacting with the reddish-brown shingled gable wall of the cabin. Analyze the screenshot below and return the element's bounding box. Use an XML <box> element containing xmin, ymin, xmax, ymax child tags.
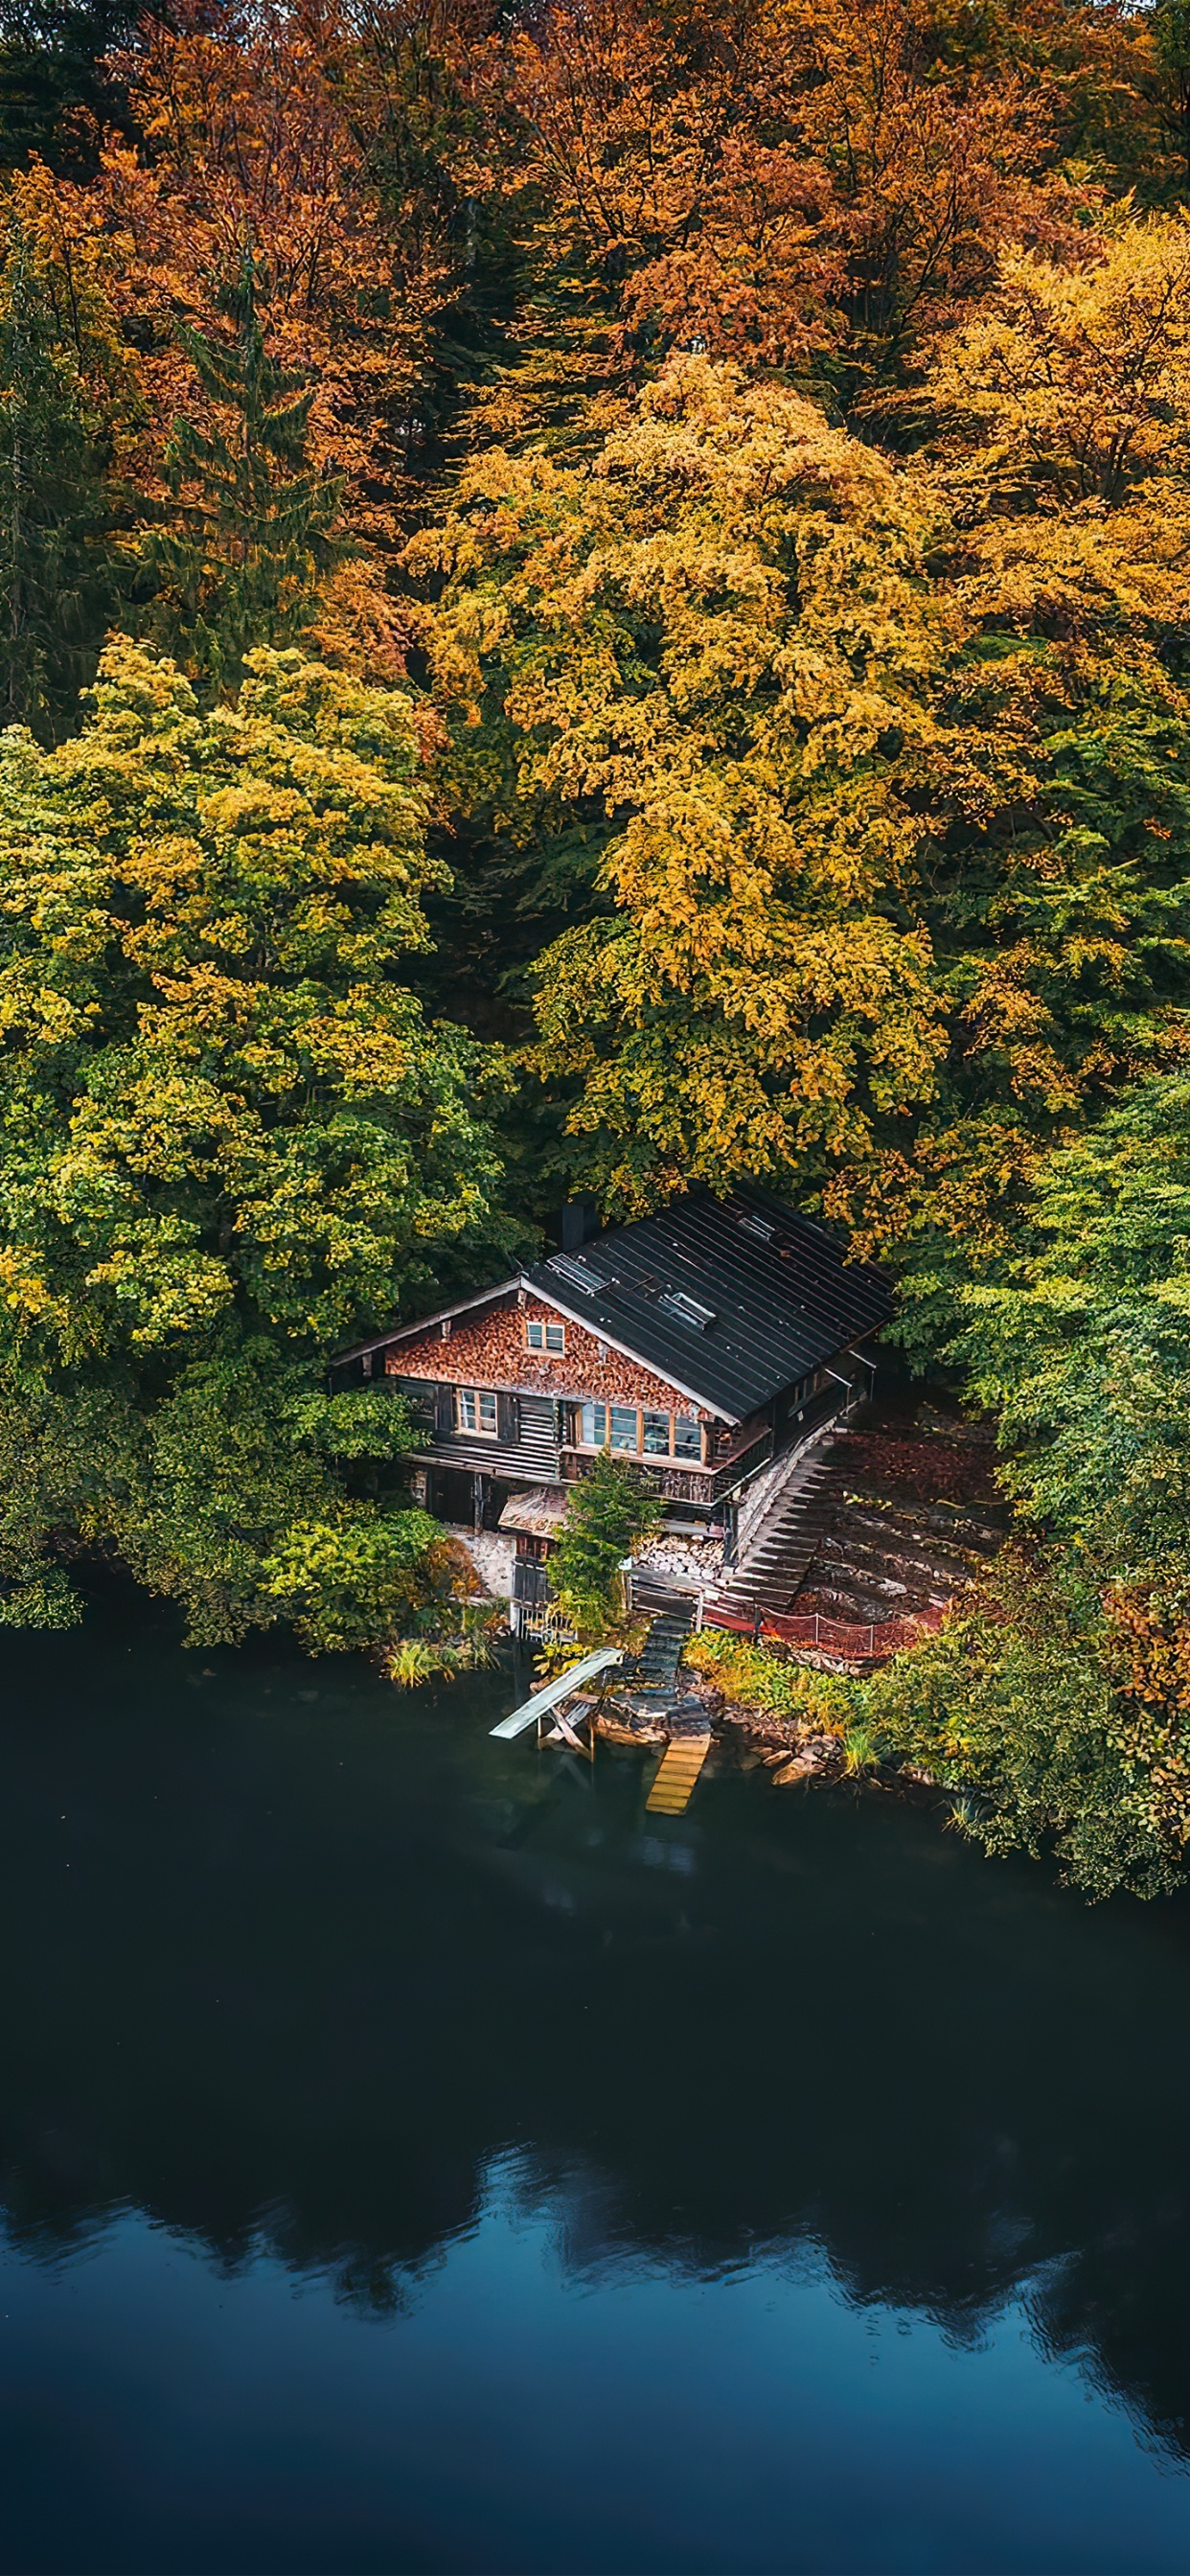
<box><xmin>384</xmin><ymin>1296</ymin><xmax>716</xmax><ymax>1422</ymax></box>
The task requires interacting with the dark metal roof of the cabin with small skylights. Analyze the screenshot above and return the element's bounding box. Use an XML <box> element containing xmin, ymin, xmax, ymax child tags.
<box><xmin>523</xmin><ymin>1184</ymin><xmax>891</xmax><ymax>1422</ymax></box>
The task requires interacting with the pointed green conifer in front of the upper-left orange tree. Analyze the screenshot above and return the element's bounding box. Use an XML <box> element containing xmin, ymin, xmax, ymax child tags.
<box><xmin>145</xmin><ymin>258</ymin><xmax>345</xmax><ymax>693</ymax></box>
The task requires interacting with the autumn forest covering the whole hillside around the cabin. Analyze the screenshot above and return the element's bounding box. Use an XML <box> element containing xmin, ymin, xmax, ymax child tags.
<box><xmin>0</xmin><ymin>0</ymin><xmax>1190</xmax><ymax>1888</ymax></box>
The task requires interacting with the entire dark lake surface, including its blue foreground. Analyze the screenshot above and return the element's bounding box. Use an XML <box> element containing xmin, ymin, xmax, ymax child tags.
<box><xmin>0</xmin><ymin>1613</ymin><xmax>1190</xmax><ymax>2576</ymax></box>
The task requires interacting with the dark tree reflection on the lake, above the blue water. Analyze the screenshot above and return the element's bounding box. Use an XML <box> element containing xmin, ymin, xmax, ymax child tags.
<box><xmin>0</xmin><ymin>1621</ymin><xmax>1190</xmax><ymax>2457</ymax></box>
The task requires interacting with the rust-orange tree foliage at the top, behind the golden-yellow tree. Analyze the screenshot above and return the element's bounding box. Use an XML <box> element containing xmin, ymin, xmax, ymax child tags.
<box><xmin>463</xmin><ymin>0</ymin><xmax>1164</xmax><ymax>450</ymax></box>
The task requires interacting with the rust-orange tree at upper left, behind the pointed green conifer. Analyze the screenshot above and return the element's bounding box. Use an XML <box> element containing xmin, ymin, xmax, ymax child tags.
<box><xmin>87</xmin><ymin>5</ymin><xmax>479</xmax><ymax>559</ymax></box>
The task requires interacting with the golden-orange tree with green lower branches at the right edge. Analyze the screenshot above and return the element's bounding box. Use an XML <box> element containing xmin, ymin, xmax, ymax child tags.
<box><xmin>881</xmin><ymin>217</ymin><xmax>1190</xmax><ymax>1308</ymax></box>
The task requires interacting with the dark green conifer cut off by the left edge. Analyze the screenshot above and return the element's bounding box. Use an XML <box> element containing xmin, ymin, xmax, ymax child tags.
<box><xmin>0</xmin><ymin>221</ymin><xmax>116</xmax><ymax>742</ymax></box>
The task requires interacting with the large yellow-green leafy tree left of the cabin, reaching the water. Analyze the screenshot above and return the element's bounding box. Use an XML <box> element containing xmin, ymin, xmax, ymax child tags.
<box><xmin>0</xmin><ymin>639</ymin><xmax>505</xmax><ymax>1646</ymax></box>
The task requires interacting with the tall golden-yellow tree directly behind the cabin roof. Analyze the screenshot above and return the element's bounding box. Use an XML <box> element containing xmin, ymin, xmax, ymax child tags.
<box><xmin>409</xmin><ymin>360</ymin><xmax>946</xmax><ymax>1206</ymax></box>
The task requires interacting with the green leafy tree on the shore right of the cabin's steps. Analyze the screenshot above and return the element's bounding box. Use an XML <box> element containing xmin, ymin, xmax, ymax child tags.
<box><xmin>868</xmin><ymin>1074</ymin><xmax>1190</xmax><ymax>1896</ymax></box>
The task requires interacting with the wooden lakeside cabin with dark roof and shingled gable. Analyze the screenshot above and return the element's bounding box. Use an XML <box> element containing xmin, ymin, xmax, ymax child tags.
<box><xmin>334</xmin><ymin>1187</ymin><xmax>891</xmax><ymax>1597</ymax></box>
